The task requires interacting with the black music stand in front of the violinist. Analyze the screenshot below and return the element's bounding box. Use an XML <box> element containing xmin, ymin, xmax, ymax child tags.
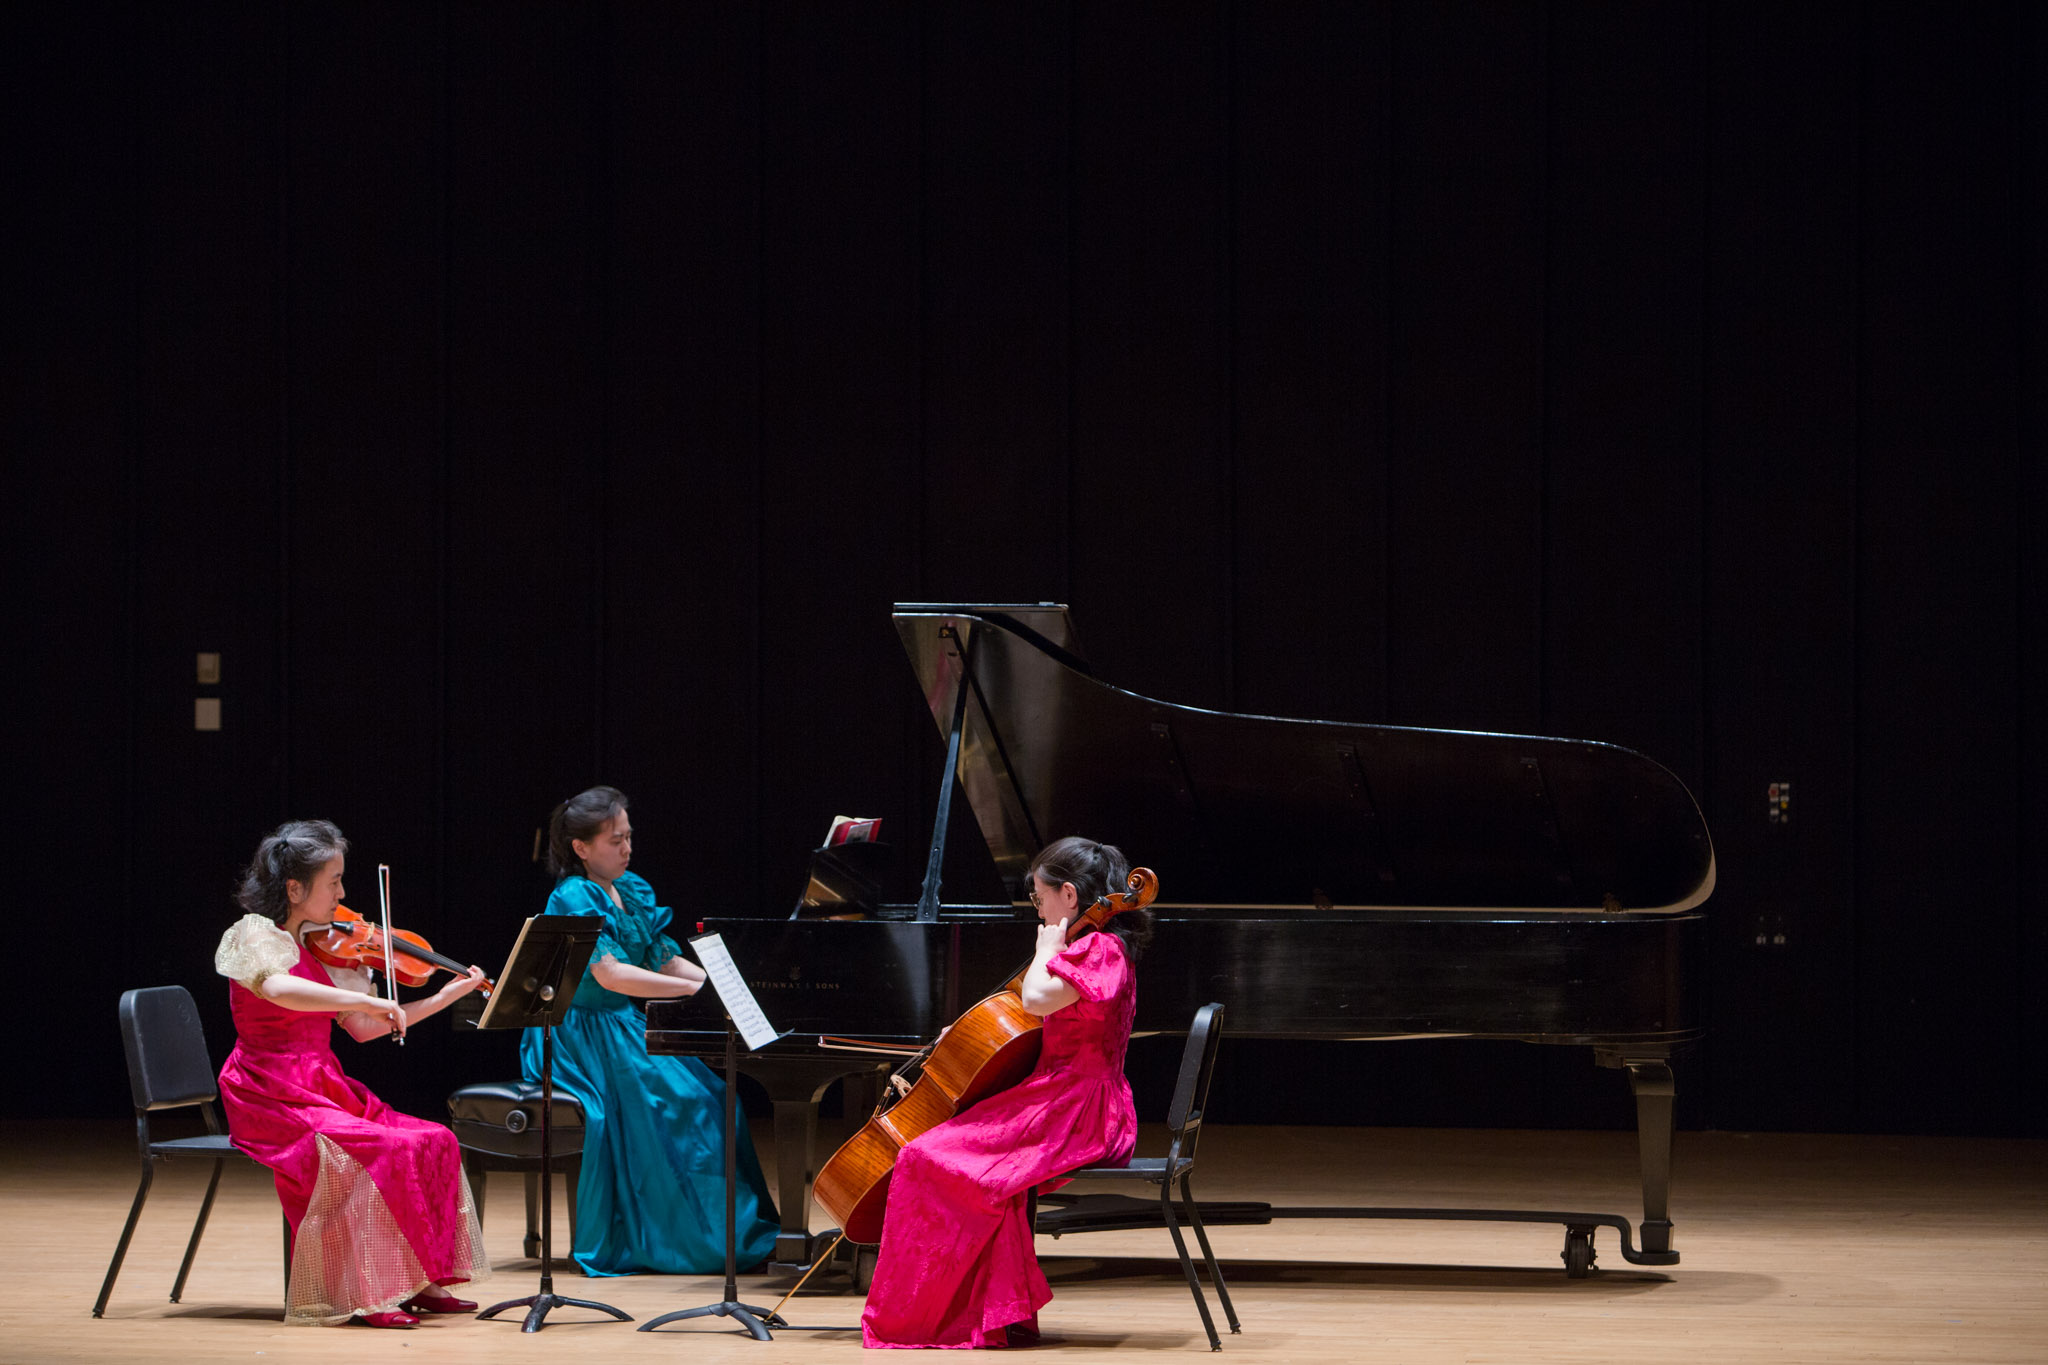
<box><xmin>477</xmin><ymin>915</ymin><xmax>633</xmax><ymax>1332</ymax></box>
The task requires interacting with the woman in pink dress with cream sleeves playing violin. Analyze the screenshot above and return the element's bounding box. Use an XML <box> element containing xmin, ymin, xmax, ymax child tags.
<box><xmin>213</xmin><ymin>821</ymin><xmax>489</xmax><ymax>1326</ymax></box>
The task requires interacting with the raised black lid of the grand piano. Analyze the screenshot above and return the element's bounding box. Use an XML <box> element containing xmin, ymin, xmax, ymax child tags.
<box><xmin>895</xmin><ymin>604</ymin><xmax>1714</xmax><ymax>913</ymax></box>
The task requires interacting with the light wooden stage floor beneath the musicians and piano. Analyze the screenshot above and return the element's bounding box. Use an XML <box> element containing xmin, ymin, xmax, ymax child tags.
<box><xmin>0</xmin><ymin>1121</ymin><xmax>2048</xmax><ymax>1365</ymax></box>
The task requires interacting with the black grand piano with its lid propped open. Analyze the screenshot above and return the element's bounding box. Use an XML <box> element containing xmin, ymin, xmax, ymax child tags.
<box><xmin>647</xmin><ymin>604</ymin><xmax>1714</xmax><ymax>1275</ymax></box>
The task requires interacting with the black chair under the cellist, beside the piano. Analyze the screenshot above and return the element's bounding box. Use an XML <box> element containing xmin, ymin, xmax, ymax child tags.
<box><xmin>1030</xmin><ymin>1005</ymin><xmax>1243</xmax><ymax>1351</ymax></box>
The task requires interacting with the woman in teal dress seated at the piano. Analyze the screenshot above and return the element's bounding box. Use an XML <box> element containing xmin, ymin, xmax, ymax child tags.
<box><xmin>520</xmin><ymin>786</ymin><xmax>776</xmax><ymax>1275</ymax></box>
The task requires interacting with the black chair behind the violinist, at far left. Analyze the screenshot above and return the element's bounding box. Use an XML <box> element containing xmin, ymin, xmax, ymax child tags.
<box><xmin>92</xmin><ymin>986</ymin><xmax>291</xmax><ymax>1318</ymax></box>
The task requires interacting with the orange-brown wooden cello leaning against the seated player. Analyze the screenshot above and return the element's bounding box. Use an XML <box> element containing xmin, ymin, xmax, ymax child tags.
<box><xmin>811</xmin><ymin>868</ymin><xmax>1159</xmax><ymax>1246</ymax></box>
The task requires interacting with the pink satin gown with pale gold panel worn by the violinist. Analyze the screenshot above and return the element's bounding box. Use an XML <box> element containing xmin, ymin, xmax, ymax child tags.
<box><xmin>221</xmin><ymin>948</ymin><xmax>489</xmax><ymax>1322</ymax></box>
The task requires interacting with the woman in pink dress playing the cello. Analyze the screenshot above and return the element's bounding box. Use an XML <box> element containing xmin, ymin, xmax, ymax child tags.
<box><xmin>860</xmin><ymin>837</ymin><xmax>1151</xmax><ymax>1347</ymax></box>
